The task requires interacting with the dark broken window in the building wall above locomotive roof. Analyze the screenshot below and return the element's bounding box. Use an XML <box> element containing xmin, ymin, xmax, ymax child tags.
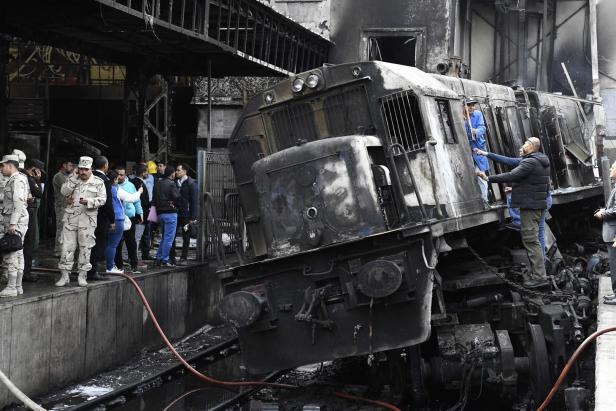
<box><xmin>368</xmin><ymin>35</ymin><xmax>417</xmax><ymax>66</ymax></box>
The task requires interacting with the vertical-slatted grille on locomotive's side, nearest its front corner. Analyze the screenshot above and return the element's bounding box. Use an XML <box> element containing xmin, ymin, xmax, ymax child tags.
<box><xmin>381</xmin><ymin>91</ymin><xmax>426</xmax><ymax>151</ymax></box>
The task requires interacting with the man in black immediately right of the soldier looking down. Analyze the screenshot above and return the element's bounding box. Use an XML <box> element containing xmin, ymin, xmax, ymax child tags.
<box><xmin>88</xmin><ymin>156</ymin><xmax>115</xmax><ymax>281</ymax></box>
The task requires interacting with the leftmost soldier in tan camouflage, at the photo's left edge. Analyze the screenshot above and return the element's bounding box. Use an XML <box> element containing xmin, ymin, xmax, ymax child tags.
<box><xmin>0</xmin><ymin>155</ymin><xmax>29</xmax><ymax>297</ymax></box>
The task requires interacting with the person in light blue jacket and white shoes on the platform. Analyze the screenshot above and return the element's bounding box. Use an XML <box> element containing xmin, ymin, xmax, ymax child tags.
<box><xmin>115</xmin><ymin>166</ymin><xmax>143</xmax><ymax>273</ymax></box>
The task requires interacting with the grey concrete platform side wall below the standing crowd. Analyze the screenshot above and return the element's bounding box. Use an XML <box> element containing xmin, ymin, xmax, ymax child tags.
<box><xmin>0</xmin><ymin>264</ymin><xmax>221</xmax><ymax>407</ymax></box>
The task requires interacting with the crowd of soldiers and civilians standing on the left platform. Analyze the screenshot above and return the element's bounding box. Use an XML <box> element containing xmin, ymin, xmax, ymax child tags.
<box><xmin>0</xmin><ymin>150</ymin><xmax>199</xmax><ymax>297</ymax></box>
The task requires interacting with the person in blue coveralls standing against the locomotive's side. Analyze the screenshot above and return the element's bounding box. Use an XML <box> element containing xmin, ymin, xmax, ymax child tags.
<box><xmin>462</xmin><ymin>98</ymin><xmax>490</xmax><ymax>203</ymax></box>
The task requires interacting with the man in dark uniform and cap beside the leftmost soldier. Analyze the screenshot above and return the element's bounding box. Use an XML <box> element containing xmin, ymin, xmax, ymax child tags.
<box><xmin>20</xmin><ymin>158</ymin><xmax>45</xmax><ymax>281</ymax></box>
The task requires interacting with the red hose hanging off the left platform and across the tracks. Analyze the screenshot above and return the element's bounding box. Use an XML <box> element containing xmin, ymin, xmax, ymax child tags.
<box><xmin>109</xmin><ymin>273</ymin><xmax>400</xmax><ymax>411</ymax></box>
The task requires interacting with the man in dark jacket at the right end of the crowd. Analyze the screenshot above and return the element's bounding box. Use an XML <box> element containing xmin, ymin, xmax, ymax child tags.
<box><xmin>171</xmin><ymin>163</ymin><xmax>199</xmax><ymax>264</ymax></box>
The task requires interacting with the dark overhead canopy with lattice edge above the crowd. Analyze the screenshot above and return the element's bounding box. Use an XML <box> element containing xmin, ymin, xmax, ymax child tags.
<box><xmin>0</xmin><ymin>0</ymin><xmax>331</xmax><ymax>77</ymax></box>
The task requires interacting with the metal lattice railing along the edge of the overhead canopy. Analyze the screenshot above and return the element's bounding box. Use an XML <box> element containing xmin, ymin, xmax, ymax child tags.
<box><xmin>103</xmin><ymin>0</ymin><xmax>329</xmax><ymax>73</ymax></box>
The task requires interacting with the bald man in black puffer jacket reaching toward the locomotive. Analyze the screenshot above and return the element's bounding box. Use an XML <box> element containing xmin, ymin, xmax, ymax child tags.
<box><xmin>478</xmin><ymin>137</ymin><xmax>550</xmax><ymax>287</ymax></box>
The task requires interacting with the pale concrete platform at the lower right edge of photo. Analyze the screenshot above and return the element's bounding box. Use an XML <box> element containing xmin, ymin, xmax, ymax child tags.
<box><xmin>595</xmin><ymin>277</ymin><xmax>616</xmax><ymax>411</ymax></box>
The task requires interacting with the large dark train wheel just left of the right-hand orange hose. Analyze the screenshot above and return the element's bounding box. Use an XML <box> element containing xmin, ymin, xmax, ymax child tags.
<box><xmin>528</xmin><ymin>324</ymin><xmax>552</xmax><ymax>403</ymax></box>
